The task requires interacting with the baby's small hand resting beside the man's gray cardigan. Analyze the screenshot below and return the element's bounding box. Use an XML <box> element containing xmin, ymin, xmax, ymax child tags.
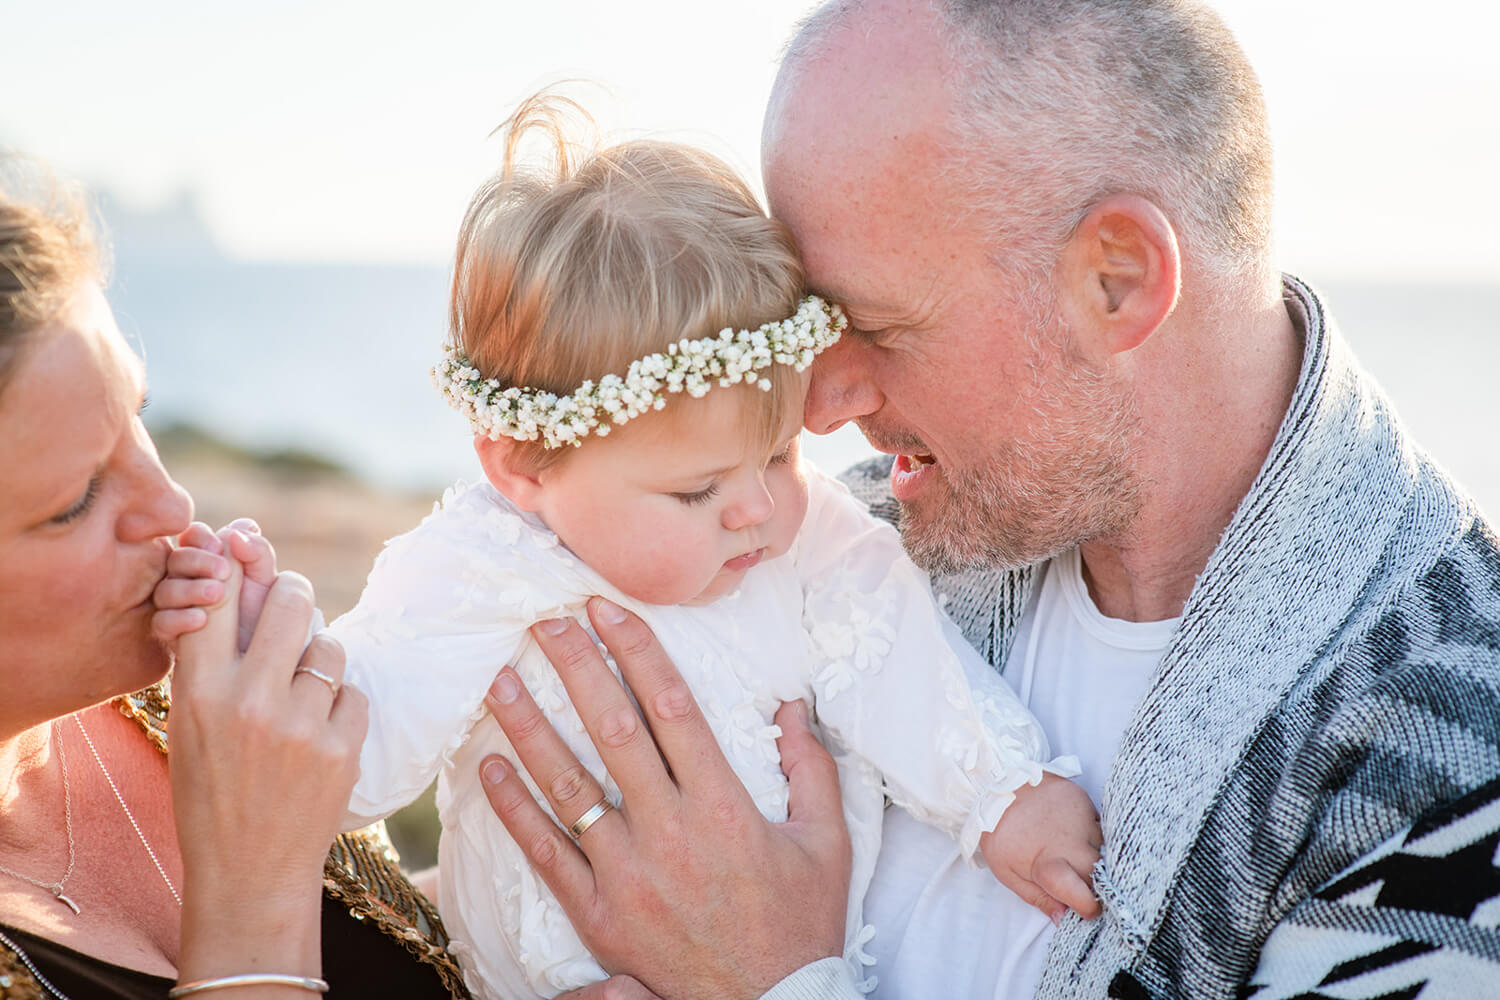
<box><xmin>980</xmin><ymin>774</ymin><xmax>1104</xmax><ymax>924</ymax></box>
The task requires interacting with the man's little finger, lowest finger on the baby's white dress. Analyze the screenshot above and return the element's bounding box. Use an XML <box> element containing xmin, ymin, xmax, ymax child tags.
<box><xmin>479</xmin><ymin>756</ymin><xmax>600</xmax><ymax>918</ymax></box>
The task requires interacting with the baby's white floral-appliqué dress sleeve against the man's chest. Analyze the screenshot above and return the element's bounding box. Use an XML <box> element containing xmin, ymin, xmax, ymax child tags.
<box><xmin>795</xmin><ymin>469</ymin><xmax>1079</xmax><ymax>859</ymax></box>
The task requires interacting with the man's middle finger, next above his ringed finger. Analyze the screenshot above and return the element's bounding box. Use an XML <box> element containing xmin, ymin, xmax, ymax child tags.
<box><xmin>522</xmin><ymin>618</ymin><xmax>675</xmax><ymax>822</ymax></box>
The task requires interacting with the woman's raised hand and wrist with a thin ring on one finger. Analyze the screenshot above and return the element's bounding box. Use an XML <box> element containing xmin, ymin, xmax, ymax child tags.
<box><xmin>168</xmin><ymin>549</ymin><xmax>366</xmax><ymax>979</ymax></box>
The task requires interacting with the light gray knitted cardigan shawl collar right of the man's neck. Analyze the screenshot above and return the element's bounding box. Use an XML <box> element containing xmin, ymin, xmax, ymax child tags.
<box><xmin>1032</xmin><ymin>276</ymin><xmax>1475</xmax><ymax>997</ymax></box>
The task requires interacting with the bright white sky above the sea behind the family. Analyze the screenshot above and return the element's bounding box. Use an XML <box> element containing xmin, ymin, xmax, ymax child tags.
<box><xmin>11</xmin><ymin>0</ymin><xmax>1500</xmax><ymax>283</ymax></box>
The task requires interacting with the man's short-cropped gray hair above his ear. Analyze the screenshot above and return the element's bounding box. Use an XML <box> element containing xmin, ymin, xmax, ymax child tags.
<box><xmin>788</xmin><ymin>0</ymin><xmax>1274</xmax><ymax>292</ymax></box>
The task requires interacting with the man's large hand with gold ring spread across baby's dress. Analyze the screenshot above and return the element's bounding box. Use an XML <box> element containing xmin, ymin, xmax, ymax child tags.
<box><xmin>480</xmin><ymin>598</ymin><xmax>851</xmax><ymax>999</ymax></box>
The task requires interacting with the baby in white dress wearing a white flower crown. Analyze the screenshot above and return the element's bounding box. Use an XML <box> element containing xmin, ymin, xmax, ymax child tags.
<box><xmin>161</xmin><ymin>97</ymin><xmax>1098</xmax><ymax>997</ymax></box>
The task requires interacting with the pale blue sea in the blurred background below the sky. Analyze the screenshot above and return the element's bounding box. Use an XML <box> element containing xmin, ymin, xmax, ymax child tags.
<box><xmin>110</xmin><ymin>246</ymin><xmax>1500</xmax><ymax>514</ymax></box>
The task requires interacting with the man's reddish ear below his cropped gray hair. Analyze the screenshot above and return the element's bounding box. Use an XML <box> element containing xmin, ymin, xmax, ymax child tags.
<box><xmin>1061</xmin><ymin>195</ymin><xmax>1182</xmax><ymax>360</ymax></box>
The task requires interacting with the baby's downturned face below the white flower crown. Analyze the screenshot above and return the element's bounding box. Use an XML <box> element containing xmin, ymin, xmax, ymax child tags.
<box><xmin>539</xmin><ymin>380</ymin><xmax>807</xmax><ymax>604</ymax></box>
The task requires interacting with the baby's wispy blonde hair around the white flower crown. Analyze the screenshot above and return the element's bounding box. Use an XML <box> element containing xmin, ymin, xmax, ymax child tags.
<box><xmin>449</xmin><ymin>93</ymin><xmax>804</xmax><ymax>468</ymax></box>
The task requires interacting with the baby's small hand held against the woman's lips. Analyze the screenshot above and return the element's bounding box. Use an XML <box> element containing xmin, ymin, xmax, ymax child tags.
<box><xmin>152</xmin><ymin>517</ymin><xmax>276</xmax><ymax>652</ymax></box>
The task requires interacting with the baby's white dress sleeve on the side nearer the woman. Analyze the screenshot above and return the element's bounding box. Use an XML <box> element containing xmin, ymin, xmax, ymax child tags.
<box><xmin>330</xmin><ymin>487</ymin><xmax>579</xmax><ymax>829</ymax></box>
